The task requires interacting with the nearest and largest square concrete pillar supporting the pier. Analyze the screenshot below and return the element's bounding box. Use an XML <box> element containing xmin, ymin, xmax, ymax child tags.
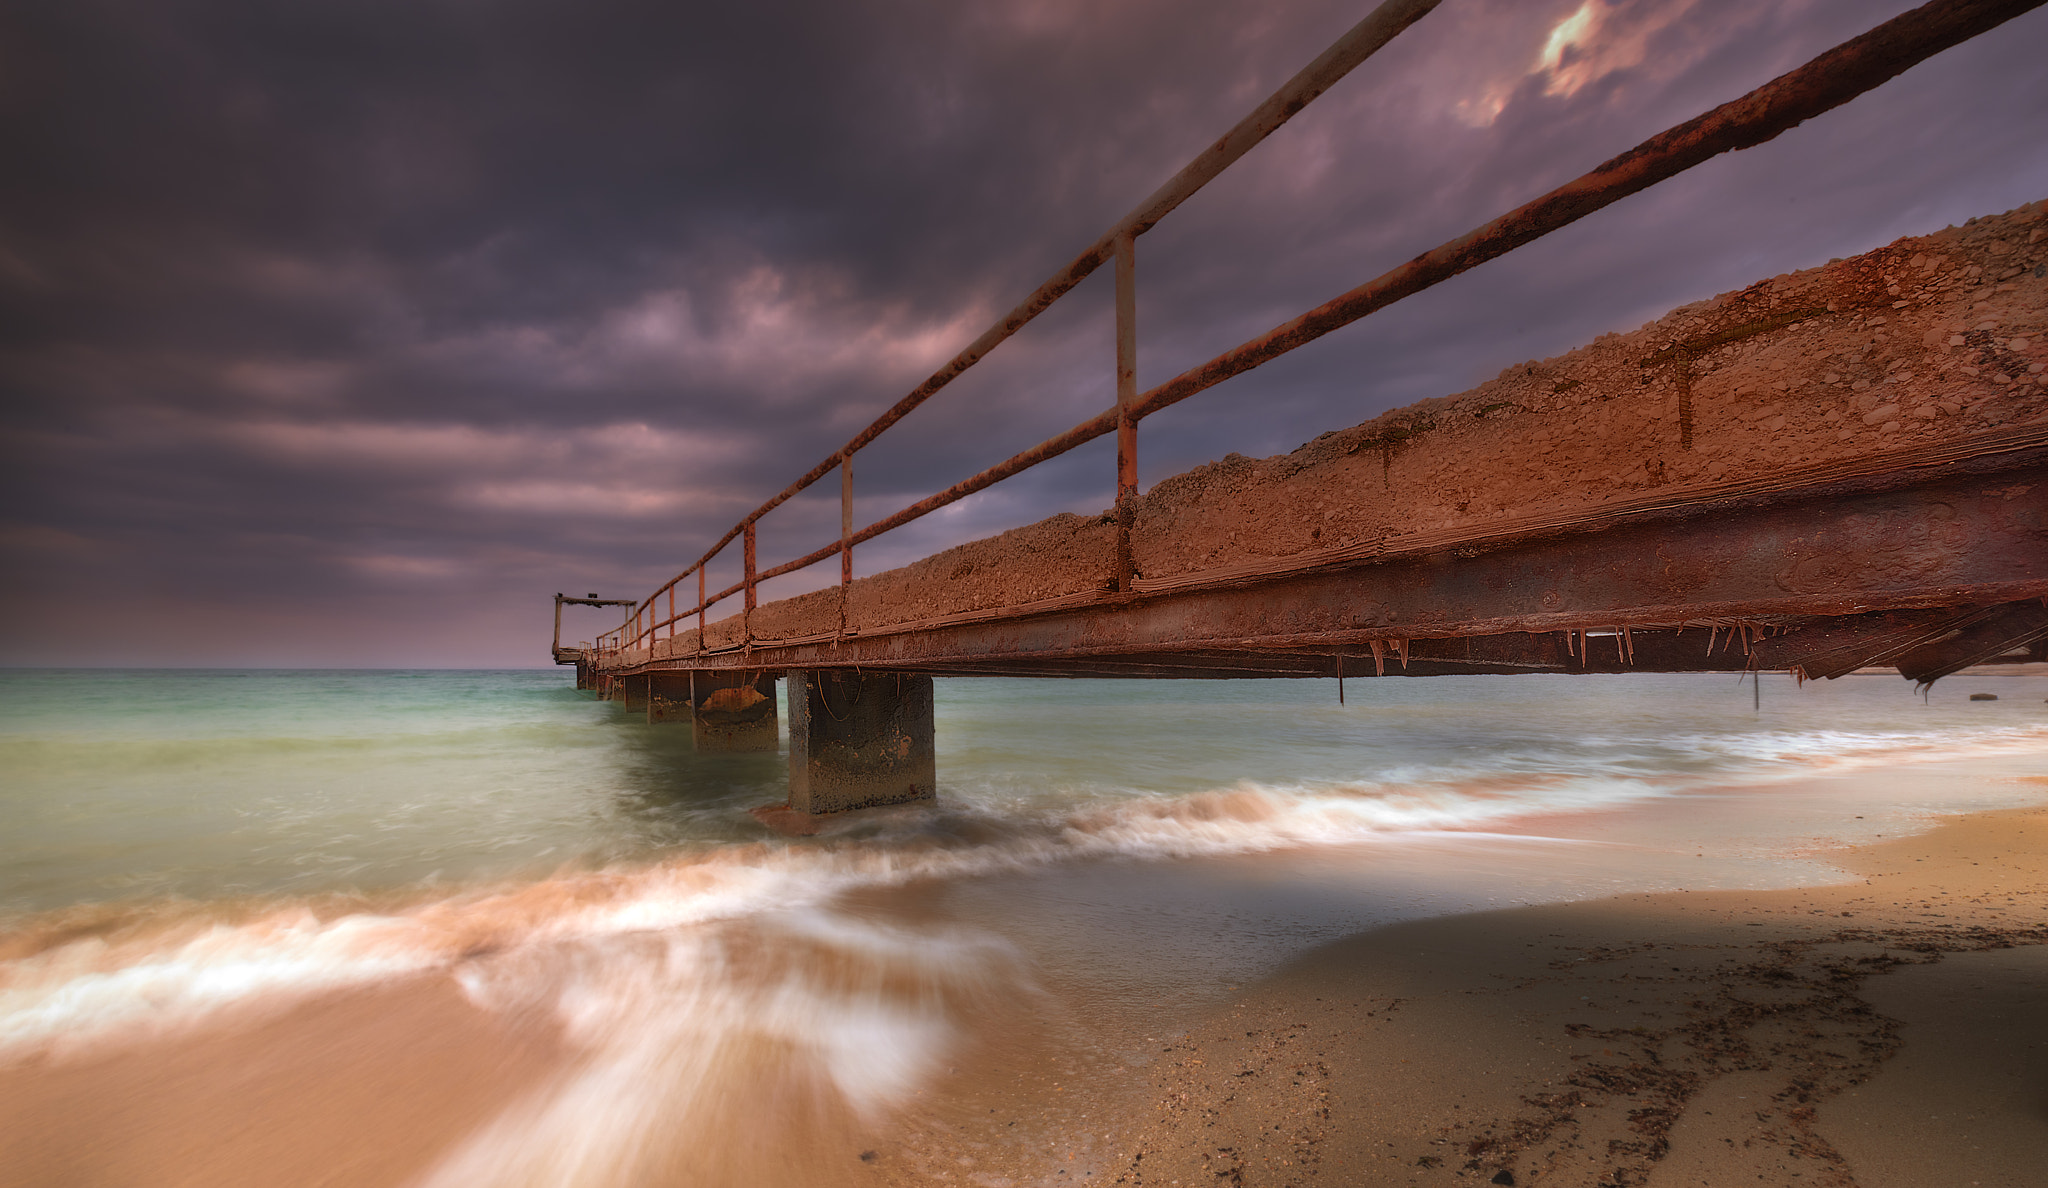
<box><xmin>788</xmin><ymin>670</ymin><xmax>938</xmax><ymax>815</ymax></box>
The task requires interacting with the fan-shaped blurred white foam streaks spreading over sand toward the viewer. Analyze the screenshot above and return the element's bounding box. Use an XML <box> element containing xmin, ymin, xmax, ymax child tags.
<box><xmin>424</xmin><ymin>909</ymin><xmax>1028</xmax><ymax>1188</ymax></box>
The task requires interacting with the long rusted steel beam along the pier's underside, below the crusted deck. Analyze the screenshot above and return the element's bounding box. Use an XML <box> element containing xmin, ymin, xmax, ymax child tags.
<box><xmin>610</xmin><ymin>458</ymin><xmax>2048</xmax><ymax>676</ymax></box>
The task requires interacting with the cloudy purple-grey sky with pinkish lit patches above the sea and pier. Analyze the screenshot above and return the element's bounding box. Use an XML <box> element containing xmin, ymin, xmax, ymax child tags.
<box><xmin>0</xmin><ymin>0</ymin><xmax>2048</xmax><ymax>668</ymax></box>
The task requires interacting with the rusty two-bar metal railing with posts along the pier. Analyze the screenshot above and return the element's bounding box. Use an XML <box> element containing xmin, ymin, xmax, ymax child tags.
<box><xmin>596</xmin><ymin>0</ymin><xmax>2048</xmax><ymax>653</ymax></box>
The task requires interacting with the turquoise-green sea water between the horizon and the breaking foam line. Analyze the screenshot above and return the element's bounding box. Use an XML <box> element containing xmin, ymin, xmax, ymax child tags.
<box><xmin>0</xmin><ymin>670</ymin><xmax>2048</xmax><ymax>914</ymax></box>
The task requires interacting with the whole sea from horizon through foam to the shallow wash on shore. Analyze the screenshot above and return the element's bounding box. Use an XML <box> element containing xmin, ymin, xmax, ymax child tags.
<box><xmin>0</xmin><ymin>666</ymin><xmax>2048</xmax><ymax>1186</ymax></box>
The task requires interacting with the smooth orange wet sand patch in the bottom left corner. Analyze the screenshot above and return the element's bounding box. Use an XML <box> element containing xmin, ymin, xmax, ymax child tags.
<box><xmin>0</xmin><ymin>977</ymin><xmax>561</xmax><ymax>1188</ymax></box>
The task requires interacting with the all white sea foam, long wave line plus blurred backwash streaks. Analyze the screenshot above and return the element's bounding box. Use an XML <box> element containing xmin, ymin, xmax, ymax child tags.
<box><xmin>0</xmin><ymin>696</ymin><xmax>2048</xmax><ymax>1188</ymax></box>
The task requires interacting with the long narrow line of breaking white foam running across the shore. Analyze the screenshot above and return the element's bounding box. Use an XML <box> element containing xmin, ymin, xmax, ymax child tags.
<box><xmin>16</xmin><ymin>729</ymin><xmax>2042</xmax><ymax>1055</ymax></box>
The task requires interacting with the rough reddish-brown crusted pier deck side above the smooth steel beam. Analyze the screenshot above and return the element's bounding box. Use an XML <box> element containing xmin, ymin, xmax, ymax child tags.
<box><xmin>659</xmin><ymin>201</ymin><xmax>2048</xmax><ymax>655</ymax></box>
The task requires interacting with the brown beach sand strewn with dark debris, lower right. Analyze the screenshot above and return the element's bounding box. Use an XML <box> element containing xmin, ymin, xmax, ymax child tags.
<box><xmin>879</xmin><ymin>809</ymin><xmax>2048</xmax><ymax>1188</ymax></box>
